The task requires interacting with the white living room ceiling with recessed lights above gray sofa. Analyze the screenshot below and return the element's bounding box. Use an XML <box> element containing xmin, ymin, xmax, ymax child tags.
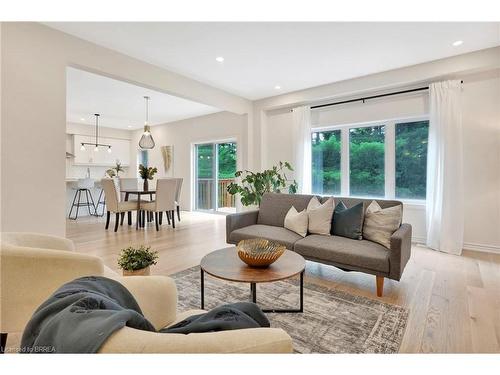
<box><xmin>51</xmin><ymin>22</ymin><xmax>500</xmax><ymax>100</ymax></box>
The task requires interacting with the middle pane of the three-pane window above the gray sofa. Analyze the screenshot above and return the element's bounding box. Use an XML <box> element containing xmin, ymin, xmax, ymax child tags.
<box><xmin>349</xmin><ymin>126</ymin><xmax>385</xmax><ymax>197</ymax></box>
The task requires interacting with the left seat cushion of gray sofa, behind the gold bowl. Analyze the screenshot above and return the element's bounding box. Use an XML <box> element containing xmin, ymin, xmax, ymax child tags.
<box><xmin>229</xmin><ymin>224</ymin><xmax>302</xmax><ymax>250</ymax></box>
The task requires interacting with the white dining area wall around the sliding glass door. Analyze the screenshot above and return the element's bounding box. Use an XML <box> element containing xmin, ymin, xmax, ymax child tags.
<box><xmin>130</xmin><ymin>112</ymin><xmax>247</xmax><ymax>210</ymax></box>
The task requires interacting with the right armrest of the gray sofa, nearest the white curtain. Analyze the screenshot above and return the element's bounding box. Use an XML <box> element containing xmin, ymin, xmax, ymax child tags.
<box><xmin>389</xmin><ymin>224</ymin><xmax>411</xmax><ymax>281</ymax></box>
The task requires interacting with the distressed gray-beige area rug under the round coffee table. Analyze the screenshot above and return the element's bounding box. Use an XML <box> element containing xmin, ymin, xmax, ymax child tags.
<box><xmin>172</xmin><ymin>267</ymin><xmax>408</xmax><ymax>353</ymax></box>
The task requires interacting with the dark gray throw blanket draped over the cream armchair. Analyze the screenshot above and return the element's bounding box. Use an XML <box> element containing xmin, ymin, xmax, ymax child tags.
<box><xmin>21</xmin><ymin>276</ymin><xmax>270</xmax><ymax>353</ymax></box>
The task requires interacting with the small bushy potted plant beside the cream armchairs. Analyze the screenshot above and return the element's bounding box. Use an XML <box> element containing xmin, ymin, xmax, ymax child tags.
<box><xmin>118</xmin><ymin>245</ymin><xmax>158</xmax><ymax>276</ymax></box>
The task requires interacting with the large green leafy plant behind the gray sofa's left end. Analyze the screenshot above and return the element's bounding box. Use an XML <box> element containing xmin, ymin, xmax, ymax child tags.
<box><xmin>227</xmin><ymin>161</ymin><xmax>298</xmax><ymax>206</ymax></box>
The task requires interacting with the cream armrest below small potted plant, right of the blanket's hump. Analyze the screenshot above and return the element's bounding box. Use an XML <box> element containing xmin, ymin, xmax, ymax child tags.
<box><xmin>114</xmin><ymin>276</ymin><xmax>177</xmax><ymax>329</ymax></box>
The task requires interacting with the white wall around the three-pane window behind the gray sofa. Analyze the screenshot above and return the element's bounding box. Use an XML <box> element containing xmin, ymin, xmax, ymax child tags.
<box><xmin>263</xmin><ymin>70</ymin><xmax>500</xmax><ymax>251</ymax></box>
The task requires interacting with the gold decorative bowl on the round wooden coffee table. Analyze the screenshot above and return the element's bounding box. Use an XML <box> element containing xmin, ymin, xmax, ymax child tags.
<box><xmin>236</xmin><ymin>238</ymin><xmax>286</xmax><ymax>268</ymax></box>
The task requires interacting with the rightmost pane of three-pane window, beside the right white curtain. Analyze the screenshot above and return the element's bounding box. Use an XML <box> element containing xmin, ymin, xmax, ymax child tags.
<box><xmin>396</xmin><ymin>121</ymin><xmax>429</xmax><ymax>199</ymax></box>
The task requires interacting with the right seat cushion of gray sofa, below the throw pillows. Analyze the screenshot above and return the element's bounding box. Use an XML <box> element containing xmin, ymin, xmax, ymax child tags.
<box><xmin>294</xmin><ymin>234</ymin><xmax>390</xmax><ymax>273</ymax></box>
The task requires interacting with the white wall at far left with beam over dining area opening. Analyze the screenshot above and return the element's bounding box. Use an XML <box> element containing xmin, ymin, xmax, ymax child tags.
<box><xmin>1</xmin><ymin>23</ymin><xmax>252</xmax><ymax>236</ymax></box>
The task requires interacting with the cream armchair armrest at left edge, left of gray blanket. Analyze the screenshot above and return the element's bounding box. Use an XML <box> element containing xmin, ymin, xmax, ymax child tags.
<box><xmin>0</xmin><ymin>248</ymin><xmax>104</xmax><ymax>333</ymax></box>
